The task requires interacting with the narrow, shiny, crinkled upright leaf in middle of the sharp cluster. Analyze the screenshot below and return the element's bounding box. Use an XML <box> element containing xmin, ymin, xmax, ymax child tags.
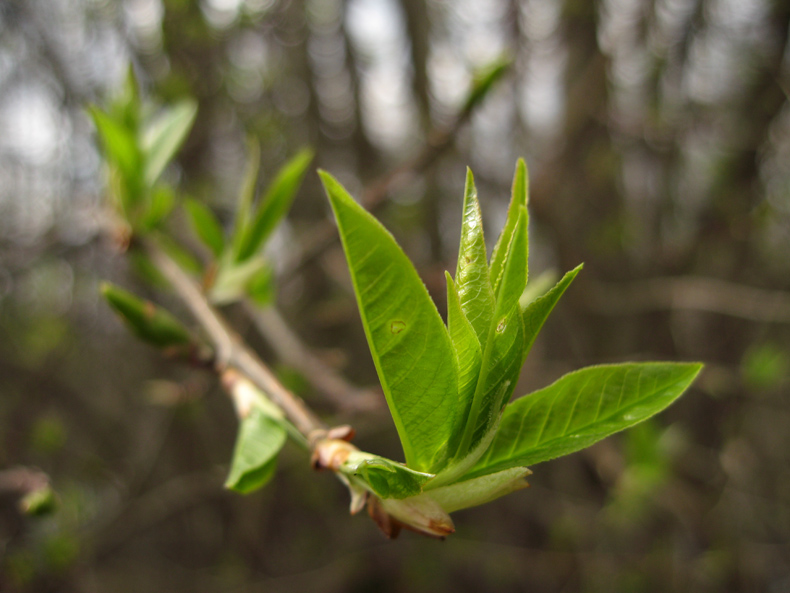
<box><xmin>455</xmin><ymin>169</ymin><xmax>496</xmax><ymax>347</ymax></box>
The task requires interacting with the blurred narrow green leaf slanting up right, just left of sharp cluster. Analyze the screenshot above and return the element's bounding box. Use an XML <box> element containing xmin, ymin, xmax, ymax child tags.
<box><xmin>236</xmin><ymin>148</ymin><xmax>313</xmax><ymax>262</ymax></box>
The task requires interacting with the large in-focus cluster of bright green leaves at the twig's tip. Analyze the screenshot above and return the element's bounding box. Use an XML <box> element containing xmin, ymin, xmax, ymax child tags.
<box><xmin>321</xmin><ymin>160</ymin><xmax>701</xmax><ymax>512</ymax></box>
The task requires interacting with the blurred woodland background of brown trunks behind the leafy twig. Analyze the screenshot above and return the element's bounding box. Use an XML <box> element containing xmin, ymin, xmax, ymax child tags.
<box><xmin>0</xmin><ymin>0</ymin><xmax>790</xmax><ymax>593</ymax></box>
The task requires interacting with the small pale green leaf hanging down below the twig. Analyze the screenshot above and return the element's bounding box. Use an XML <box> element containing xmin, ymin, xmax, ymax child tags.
<box><xmin>225</xmin><ymin>407</ymin><xmax>287</xmax><ymax>494</ymax></box>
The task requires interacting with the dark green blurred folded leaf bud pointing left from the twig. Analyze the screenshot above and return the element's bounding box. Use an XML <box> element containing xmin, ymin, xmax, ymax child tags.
<box><xmin>101</xmin><ymin>282</ymin><xmax>192</xmax><ymax>348</ymax></box>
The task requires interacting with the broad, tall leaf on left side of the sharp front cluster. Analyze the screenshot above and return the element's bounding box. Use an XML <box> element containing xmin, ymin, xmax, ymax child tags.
<box><xmin>320</xmin><ymin>171</ymin><xmax>458</xmax><ymax>473</ymax></box>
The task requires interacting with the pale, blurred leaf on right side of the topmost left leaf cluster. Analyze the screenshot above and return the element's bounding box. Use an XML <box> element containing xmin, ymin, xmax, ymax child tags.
<box><xmin>140</xmin><ymin>99</ymin><xmax>197</xmax><ymax>187</ymax></box>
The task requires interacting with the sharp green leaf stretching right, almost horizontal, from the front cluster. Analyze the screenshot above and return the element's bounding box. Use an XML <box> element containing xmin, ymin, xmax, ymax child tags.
<box><xmin>468</xmin><ymin>362</ymin><xmax>702</xmax><ymax>477</ymax></box>
